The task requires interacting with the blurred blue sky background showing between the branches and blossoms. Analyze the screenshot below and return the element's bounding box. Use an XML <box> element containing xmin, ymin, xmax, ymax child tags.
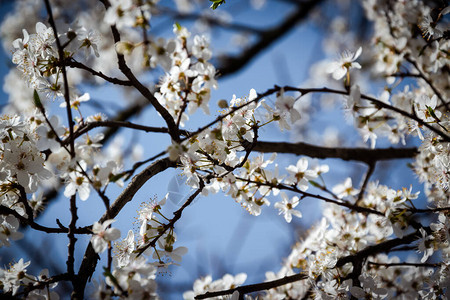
<box><xmin>0</xmin><ymin>0</ymin><xmax>418</xmax><ymax>299</ymax></box>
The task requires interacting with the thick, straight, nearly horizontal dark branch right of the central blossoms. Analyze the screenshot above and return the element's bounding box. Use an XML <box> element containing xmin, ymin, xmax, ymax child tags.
<box><xmin>253</xmin><ymin>141</ymin><xmax>418</xmax><ymax>165</ymax></box>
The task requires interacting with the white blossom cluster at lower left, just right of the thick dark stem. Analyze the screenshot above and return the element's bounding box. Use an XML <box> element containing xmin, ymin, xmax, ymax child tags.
<box><xmin>91</xmin><ymin>195</ymin><xmax>187</xmax><ymax>299</ymax></box>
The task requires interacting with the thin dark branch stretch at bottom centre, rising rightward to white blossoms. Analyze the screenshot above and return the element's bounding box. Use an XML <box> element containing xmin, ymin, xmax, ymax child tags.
<box><xmin>194</xmin><ymin>273</ymin><xmax>308</xmax><ymax>299</ymax></box>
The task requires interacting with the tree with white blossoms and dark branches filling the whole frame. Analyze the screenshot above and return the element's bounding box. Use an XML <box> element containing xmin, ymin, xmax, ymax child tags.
<box><xmin>0</xmin><ymin>0</ymin><xmax>450</xmax><ymax>299</ymax></box>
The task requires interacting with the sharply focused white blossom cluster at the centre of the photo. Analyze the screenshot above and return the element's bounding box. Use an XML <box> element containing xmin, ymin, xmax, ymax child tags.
<box><xmin>168</xmin><ymin>89</ymin><xmax>312</xmax><ymax>222</ymax></box>
